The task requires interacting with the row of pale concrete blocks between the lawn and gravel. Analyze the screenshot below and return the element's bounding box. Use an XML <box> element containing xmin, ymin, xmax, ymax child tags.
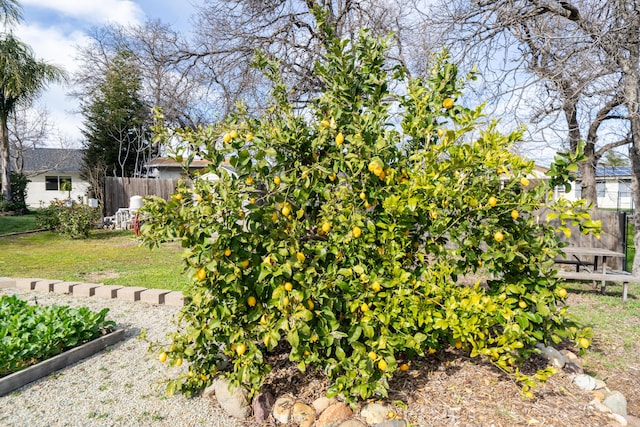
<box><xmin>0</xmin><ymin>277</ymin><xmax>184</xmax><ymax>307</ymax></box>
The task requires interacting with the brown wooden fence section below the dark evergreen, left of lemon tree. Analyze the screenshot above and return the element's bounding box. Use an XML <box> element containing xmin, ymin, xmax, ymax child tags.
<box><xmin>104</xmin><ymin>177</ymin><xmax>178</xmax><ymax>216</ymax></box>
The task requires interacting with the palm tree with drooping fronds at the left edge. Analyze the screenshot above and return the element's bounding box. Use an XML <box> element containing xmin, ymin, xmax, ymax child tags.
<box><xmin>0</xmin><ymin>0</ymin><xmax>64</xmax><ymax>202</ymax></box>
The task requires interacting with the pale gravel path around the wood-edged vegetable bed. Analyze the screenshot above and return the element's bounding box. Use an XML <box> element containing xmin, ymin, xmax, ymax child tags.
<box><xmin>0</xmin><ymin>289</ymin><xmax>246</xmax><ymax>427</ymax></box>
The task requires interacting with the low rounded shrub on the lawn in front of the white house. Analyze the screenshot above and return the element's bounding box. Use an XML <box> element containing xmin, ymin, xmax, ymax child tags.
<box><xmin>36</xmin><ymin>200</ymin><xmax>100</xmax><ymax>239</ymax></box>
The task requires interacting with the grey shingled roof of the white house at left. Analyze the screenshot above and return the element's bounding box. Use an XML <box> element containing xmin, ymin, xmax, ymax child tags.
<box><xmin>22</xmin><ymin>148</ymin><xmax>84</xmax><ymax>174</ymax></box>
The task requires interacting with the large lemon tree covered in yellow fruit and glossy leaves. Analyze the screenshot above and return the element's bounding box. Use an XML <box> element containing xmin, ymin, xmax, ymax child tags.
<box><xmin>142</xmin><ymin>20</ymin><xmax>597</xmax><ymax>399</ymax></box>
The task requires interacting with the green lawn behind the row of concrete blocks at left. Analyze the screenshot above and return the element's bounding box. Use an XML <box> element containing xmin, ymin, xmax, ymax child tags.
<box><xmin>0</xmin><ymin>230</ymin><xmax>189</xmax><ymax>290</ymax></box>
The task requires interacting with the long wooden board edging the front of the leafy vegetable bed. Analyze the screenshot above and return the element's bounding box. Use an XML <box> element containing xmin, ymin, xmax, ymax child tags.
<box><xmin>0</xmin><ymin>329</ymin><xmax>125</xmax><ymax>396</ymax></box>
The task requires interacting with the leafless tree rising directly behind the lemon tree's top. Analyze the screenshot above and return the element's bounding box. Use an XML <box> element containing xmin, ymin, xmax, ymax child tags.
<box><xmin>185</xmin><ymin>0</ymin><xmax>414</xmax><ymax>118</ymax></box>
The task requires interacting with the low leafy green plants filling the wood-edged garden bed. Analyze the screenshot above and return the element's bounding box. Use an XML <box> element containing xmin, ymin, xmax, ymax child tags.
<box><xmin>0</xmin><ymin>295</ymin><xmax>115</xmax><ymax>376</ymax></box>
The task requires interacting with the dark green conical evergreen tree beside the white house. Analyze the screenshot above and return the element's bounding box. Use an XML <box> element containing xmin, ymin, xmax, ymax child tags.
<box><xmin>81</xmin><ymin>49</ymin><xmax>152</xmax><ymax>181</ymax></box>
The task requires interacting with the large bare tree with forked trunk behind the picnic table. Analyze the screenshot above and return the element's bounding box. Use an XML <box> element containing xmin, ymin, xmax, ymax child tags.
<box><xmin>427</xmin><ymin>0</ymin><xmax>630</xmax><ymax>205</ymax></box>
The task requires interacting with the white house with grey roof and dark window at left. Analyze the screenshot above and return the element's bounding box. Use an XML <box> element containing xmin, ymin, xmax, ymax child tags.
<box><xmin>14</xmin><ymin>148</ymin><xmax>89</xmax><ymax>209</ymax></box>
